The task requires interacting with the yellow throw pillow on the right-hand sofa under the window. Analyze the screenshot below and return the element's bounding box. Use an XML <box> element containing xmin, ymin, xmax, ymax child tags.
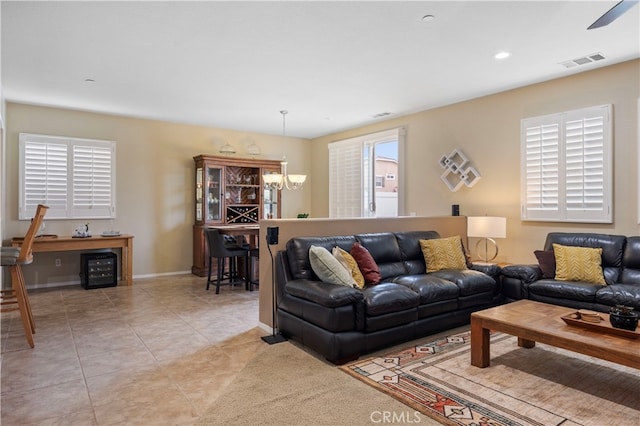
<box><xmin>553</xmin><ymin>244</ymin><xmax>607</xmax><ymax>285</ymax></box>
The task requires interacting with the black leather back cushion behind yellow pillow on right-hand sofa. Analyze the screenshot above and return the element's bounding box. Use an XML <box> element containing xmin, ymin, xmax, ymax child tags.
<box><xmin>544</xmin><ymin>232</ymin><xmax>627</xmax><ymax>284</ymax></box>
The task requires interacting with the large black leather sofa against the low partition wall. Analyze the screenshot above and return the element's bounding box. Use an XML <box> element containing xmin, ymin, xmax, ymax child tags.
<box><xmin>275</xmin><ymin>231</ymin><xmax>503</xmax><ymax>364</ymax></box>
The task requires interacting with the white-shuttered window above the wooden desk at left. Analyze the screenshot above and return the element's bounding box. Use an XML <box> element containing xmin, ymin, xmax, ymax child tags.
<box><xmin>19</xmin><ymin>133</ymin><xmax>116</xmax><ymax>220</ymax></box>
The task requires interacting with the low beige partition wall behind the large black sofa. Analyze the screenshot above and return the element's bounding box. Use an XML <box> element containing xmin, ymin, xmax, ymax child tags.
<box><xmin>259</xmin><ymin>216</ymin><xmax>467</xmax><ymax>326</ymax></box>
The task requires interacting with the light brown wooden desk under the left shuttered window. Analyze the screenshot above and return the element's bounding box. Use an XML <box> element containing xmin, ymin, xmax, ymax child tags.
<box><xmin>11</xmin><ymin>234</ymin><xmax>133</xmax><ymax>285</ymax></box>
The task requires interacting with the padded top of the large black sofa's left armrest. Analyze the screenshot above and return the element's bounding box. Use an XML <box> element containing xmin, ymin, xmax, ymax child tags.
<box><xmin>284</xmin><ymin>279</ymin><xmax>364</xmax><ymax>308</ymax></box>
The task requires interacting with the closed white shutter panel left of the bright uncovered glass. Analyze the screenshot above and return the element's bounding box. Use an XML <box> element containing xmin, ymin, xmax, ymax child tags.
<box><xmin>329</xmin><ymin>141</ymin><xmax>363</xmax><ymax>217</ymax></box>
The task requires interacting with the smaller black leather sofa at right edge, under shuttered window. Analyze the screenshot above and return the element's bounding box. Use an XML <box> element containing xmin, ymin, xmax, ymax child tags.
<box><xmin>502</xmin><ymin>232</ymin><xmax>640</xmax><ymax>312</ymax></box>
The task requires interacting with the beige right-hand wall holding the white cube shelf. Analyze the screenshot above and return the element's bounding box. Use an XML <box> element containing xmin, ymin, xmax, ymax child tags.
<box><xmin>310</xmin><ymin>60</ymin><xmax>640</xmax><ymax>263</ymax></box>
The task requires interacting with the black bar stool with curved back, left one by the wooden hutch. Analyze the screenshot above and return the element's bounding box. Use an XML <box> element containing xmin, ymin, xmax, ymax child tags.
<box><xmin>204</xmin><ymin>228</ymin><xmax>250</xmax><ymax>294</ymax></box>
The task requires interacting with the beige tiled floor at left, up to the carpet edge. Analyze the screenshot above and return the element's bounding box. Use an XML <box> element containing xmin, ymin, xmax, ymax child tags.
<box><xmin>0</xmin><ymin>275</ymin><xmax>266</xmax><ymax>426</ymax></box>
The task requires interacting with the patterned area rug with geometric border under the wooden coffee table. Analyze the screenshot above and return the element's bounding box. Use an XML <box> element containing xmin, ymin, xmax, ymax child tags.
<box><xmin>341</xmin><ymin>331</ymin><xmax>640</xmax><ymax>426</ymax></box>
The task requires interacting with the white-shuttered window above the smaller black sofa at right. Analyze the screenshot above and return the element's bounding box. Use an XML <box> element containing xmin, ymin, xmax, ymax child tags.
<box><xmin>521</xmin><ymin>105</ymin><xmax>613</xmax><ymax>223</ymax></box>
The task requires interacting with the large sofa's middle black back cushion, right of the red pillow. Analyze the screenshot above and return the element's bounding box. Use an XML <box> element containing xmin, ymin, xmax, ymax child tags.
<box><xmin>356</xmin><ymin>232</ymin><xmax>407</xmax><ymax>281</ymax></box>
